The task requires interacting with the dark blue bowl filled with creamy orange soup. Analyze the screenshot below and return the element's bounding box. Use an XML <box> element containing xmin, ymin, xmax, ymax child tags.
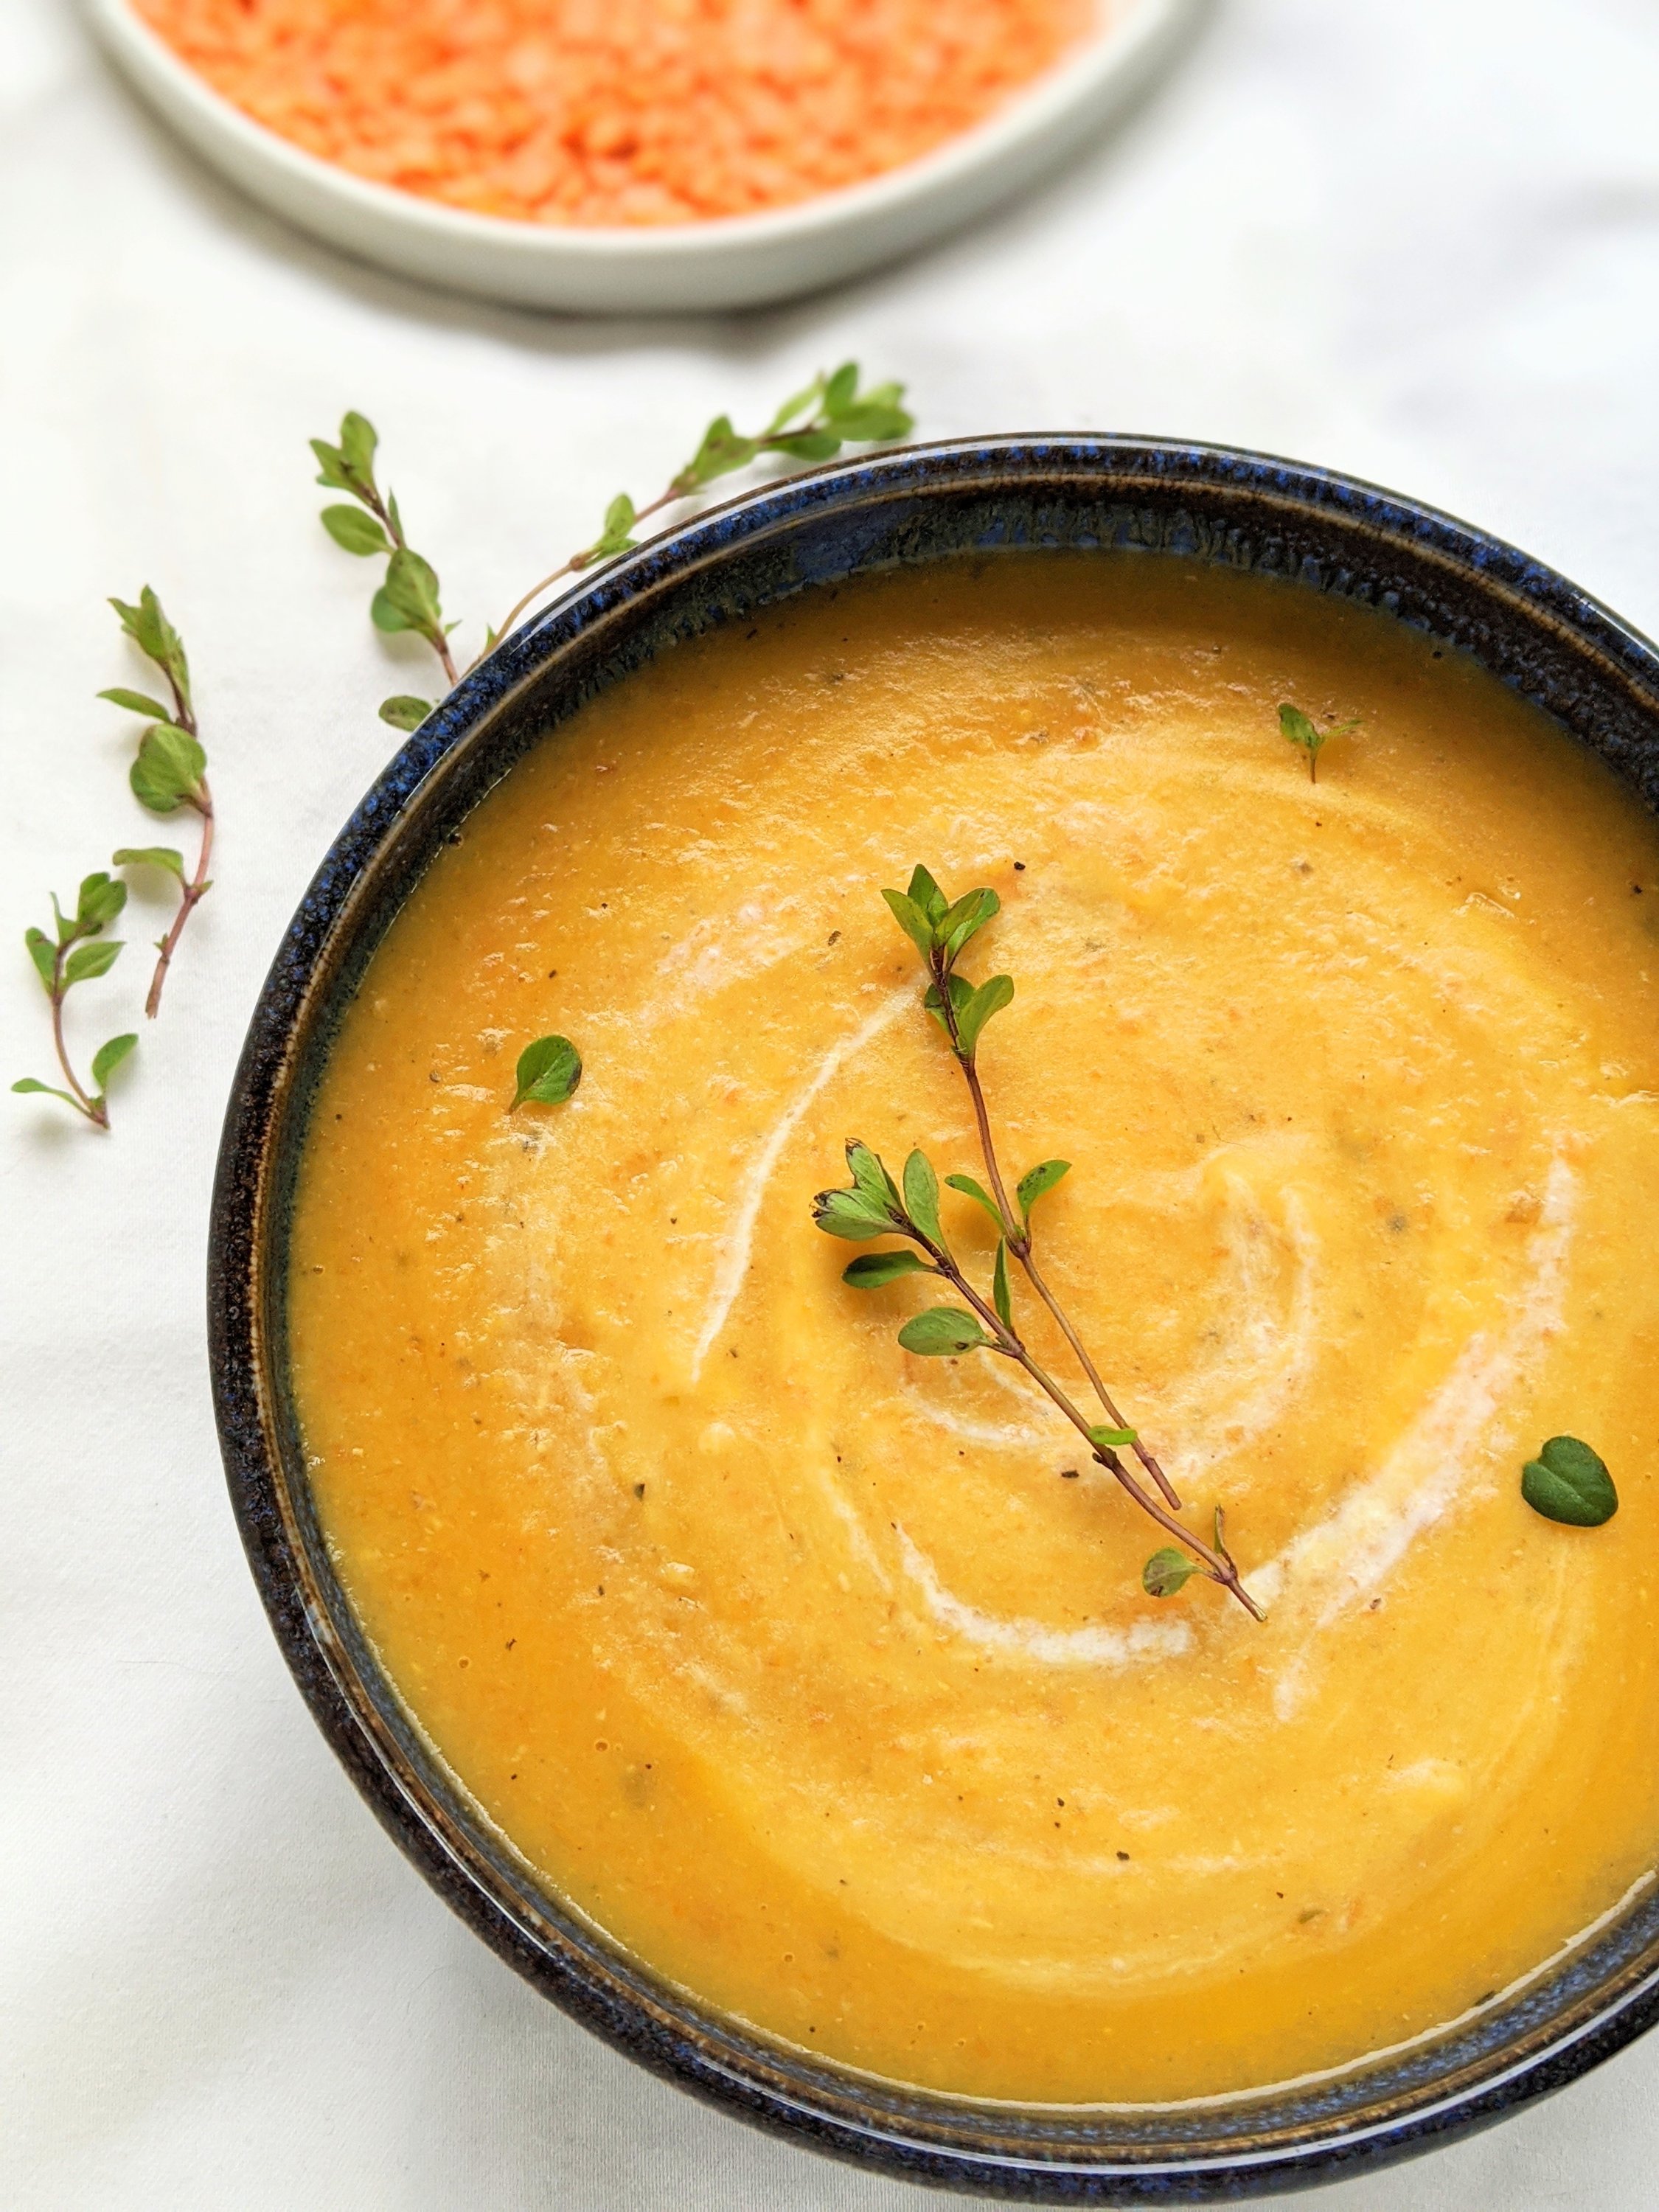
<box><xmin>210</xmin><ymin>438</ymin><xmax>1659</xmax><ymax>2203</ymax></box>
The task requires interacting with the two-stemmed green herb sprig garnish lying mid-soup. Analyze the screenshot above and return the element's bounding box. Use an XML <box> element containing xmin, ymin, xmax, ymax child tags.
<box><xmin>812</xmin><ymin>867</ymin><xmax>1263</xmax><ymax>1619</ymax></box>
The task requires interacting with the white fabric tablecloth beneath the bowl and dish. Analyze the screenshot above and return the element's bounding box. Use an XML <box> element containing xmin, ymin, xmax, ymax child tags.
<box><xmin>0</xmin><ymin>0</ymin><xmax>1659</xmax><ymax>2212</ymax></box>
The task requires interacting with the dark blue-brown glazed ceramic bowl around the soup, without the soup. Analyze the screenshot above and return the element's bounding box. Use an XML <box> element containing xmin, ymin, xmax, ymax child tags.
<box><xmin>210</xmin><ymin>438</ymin><xmax>1659</xmax><ymax>2205</ymax></box>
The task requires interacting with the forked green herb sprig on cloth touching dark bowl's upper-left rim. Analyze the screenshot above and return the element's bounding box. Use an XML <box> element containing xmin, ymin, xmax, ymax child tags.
<box><xmin>312</xmin><ymin>361</ymin><xmax>914</xmax><ymax>730</ymax></box>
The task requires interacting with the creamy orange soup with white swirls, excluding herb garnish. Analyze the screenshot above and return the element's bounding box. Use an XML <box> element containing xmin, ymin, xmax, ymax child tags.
<box><xmin>290</xmin><ymin>553</ymin><xmax>1659</xmax><ymax>2101</ymax></box>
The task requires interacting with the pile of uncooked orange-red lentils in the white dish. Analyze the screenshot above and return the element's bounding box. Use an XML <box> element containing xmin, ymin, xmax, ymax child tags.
<box><xmin>137</xmin><ymin>0</ymin><xmax>1099</xmax><ymax>223</ymax></box>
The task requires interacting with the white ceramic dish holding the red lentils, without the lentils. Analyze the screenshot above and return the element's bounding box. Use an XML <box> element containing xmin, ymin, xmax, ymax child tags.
<box><xmin>86</xmin><ymin>0</ymin><xmax>1201</xmax><ymax>314</ymax></box>
